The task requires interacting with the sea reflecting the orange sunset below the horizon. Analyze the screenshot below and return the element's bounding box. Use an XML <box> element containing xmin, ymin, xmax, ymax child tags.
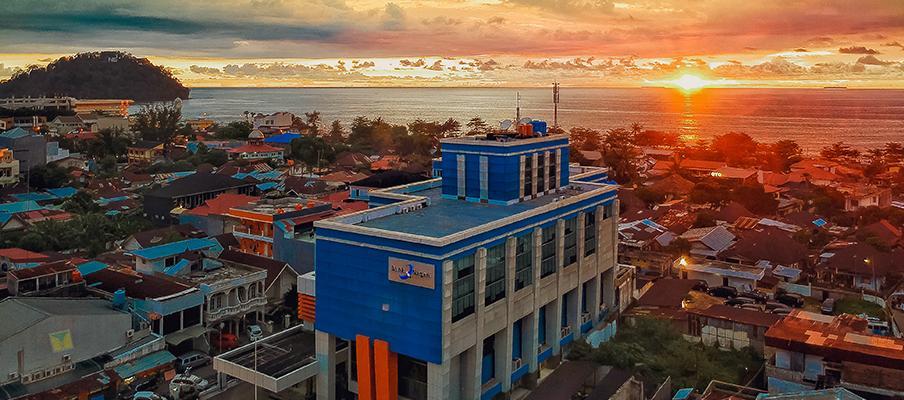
<box><xmin>170</xmin><ymin>88</ymin><xmax>904</xmax><ymax>153</ymax></box>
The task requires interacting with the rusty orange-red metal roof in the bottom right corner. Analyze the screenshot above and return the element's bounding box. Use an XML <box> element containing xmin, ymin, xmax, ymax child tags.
<box><xmin>766</xmin><ymin>310</ymin><xmax>904</xmax><ymax>369</ymax></box>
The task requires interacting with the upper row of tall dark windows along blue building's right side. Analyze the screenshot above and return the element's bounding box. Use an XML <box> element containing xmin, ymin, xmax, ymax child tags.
<box><xmin>452</xmin><ymin>205</ymin><xmax>612</xmax><ymax>322</ymax></box>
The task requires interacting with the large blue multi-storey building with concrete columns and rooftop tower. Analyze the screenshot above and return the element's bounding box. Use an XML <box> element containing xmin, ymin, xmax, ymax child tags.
<box><xmin>315</xmin><ymin>135</ymin><xmax>618</xmax><ymax>400</ymax></box>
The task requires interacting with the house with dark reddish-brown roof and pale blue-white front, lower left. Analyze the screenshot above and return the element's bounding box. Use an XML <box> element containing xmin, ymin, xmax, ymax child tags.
<box><xmin>85</xmin><ymin>268</ymin><xmax>207</xmax><ymax>353</ymax></box>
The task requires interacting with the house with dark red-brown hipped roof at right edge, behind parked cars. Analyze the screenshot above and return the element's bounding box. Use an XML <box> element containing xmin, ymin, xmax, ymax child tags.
<box><xmin>815</xmin><ymin>242</ymin><xmax>904</xmax><ymax>292</ymax></box>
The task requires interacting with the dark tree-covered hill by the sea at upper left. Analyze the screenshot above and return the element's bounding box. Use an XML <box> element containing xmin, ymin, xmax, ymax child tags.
<box><xmin>0</xmin><ymin>51</ymin><xmax>190</xmax><ymax>102</ymax></box>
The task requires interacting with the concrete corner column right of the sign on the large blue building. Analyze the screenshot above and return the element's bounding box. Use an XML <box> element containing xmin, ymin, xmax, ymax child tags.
<box><xmin>427</xmin><ymin>260</ymin><xmax>459</xmax><ymax>400</ymax></box>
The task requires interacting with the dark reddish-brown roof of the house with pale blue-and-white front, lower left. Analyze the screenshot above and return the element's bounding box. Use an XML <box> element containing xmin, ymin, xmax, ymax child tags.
<box><xmin>85</xmin><ymin>268</ymin><xmax>194</xmax><ymax>299</ymax></box>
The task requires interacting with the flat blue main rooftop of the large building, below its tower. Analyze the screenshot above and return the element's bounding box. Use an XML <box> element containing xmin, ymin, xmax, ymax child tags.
<box><xmin>338</xmin><ymin>180</ymin><xmax>615</xmax><ymax>238</ymax></box>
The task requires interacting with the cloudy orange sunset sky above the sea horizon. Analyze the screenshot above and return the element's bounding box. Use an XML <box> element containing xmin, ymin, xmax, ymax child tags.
<box><xmin>0</xmin><ymin>0</ymin><xmax>904</xmax><ymax>88</ymax></box>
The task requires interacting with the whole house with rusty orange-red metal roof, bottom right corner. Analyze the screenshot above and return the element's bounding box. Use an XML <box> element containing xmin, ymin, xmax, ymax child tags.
<box><xmin>765</xmin><ymin>310</ymin><xmax>904</xmax><ymax>399</ymax></box>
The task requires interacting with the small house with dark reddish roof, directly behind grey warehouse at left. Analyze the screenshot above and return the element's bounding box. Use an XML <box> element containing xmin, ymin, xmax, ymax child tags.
<box><xmin>6</xmin><ymin>260</ymin><xmax>85</xmax><ymax>297</ymax></box>
